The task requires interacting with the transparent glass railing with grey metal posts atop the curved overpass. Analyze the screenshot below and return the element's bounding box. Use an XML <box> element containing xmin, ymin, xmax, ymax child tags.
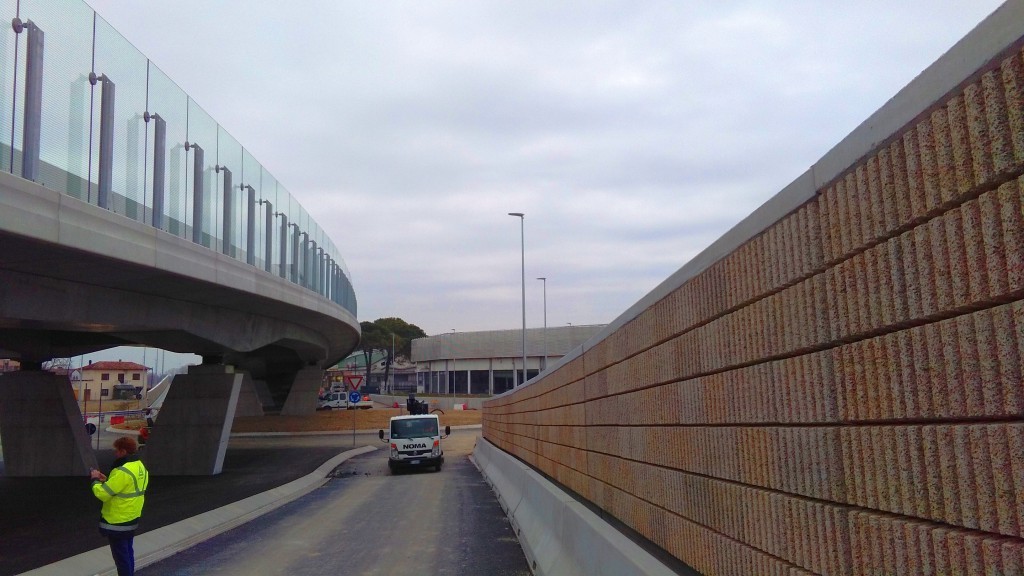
<box><xmin>0</xmin><ymin>0</ymin><xmax>356</xmax><ymax>316</ymax></box>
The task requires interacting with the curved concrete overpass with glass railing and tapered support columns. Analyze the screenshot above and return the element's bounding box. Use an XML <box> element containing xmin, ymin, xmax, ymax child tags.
<box><xmin>0</xmin><ymin>2</ymin><xmax>359</xmax><ymax>476</ymax></box>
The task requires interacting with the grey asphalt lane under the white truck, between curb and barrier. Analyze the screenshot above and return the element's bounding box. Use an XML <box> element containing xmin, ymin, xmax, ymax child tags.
<box><xmin>137</xmin><ymin>429</ymin><xmax>529</xmax><ymax>576</ymax></box>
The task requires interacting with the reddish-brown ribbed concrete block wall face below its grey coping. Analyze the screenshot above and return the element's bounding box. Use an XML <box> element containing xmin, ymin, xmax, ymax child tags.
<box><xmin>483</xmin><ymin>7</ymin><xmax>1024</xmax><ymax>575</ymax></box>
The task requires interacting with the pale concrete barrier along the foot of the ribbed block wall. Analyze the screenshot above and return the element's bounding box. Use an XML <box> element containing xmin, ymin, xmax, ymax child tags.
<box><xmin>473</xmin><ymin>438</ymin><xmax>676</xmax><ymax>576</ymax></box>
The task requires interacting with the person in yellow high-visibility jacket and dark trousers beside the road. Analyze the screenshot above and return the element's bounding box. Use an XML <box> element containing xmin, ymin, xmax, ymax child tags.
<box><xmin>89</xmin><ymin>436</ymin><xmax>150</xmax><ymax>576</ymax></box>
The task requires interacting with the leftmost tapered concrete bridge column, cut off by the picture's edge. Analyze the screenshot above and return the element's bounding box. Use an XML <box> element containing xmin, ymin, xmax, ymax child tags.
<box><xmin>0</xmin><ymin>371</ymin><xmax>96</xmax><ymax>478</ymax></box>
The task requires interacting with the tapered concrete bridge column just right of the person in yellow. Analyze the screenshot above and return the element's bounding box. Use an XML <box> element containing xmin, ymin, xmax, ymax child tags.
<box><xmin>143</xmin><ymin>365</ymin><xmax>245</xmax><ymax>476</ymax></box>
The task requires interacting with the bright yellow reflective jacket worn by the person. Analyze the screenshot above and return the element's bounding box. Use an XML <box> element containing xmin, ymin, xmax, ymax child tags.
<box><xmin>92</xmin><ymin>456</ymin><xmax>150</xmax><ymax>532</ymax></box>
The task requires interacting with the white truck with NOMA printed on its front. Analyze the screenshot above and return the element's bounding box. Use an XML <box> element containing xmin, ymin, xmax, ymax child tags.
<box><xmin>377</xmin><ymin>414</ymin><xmax>452</xmax><ymax>474</ymax></box>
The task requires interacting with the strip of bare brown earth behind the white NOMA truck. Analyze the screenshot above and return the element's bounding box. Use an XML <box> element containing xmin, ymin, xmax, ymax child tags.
<box><xmin>231</xmin><ymin>408</ymin><xmax>482</xmax><ymax>433</ymax></box>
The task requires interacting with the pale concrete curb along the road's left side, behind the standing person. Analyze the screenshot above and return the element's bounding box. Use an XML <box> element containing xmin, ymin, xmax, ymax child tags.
<box><xmin>22</xmin><ymin>440</ymin><xmax>377</xmax><ymax>576</ymax></box>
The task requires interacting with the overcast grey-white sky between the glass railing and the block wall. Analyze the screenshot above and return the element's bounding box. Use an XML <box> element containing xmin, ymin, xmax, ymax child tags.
<box><xmin>81</xmin><ymin>0</ymin><xmax>1001</xmax><ymax>334</ymax></box>
